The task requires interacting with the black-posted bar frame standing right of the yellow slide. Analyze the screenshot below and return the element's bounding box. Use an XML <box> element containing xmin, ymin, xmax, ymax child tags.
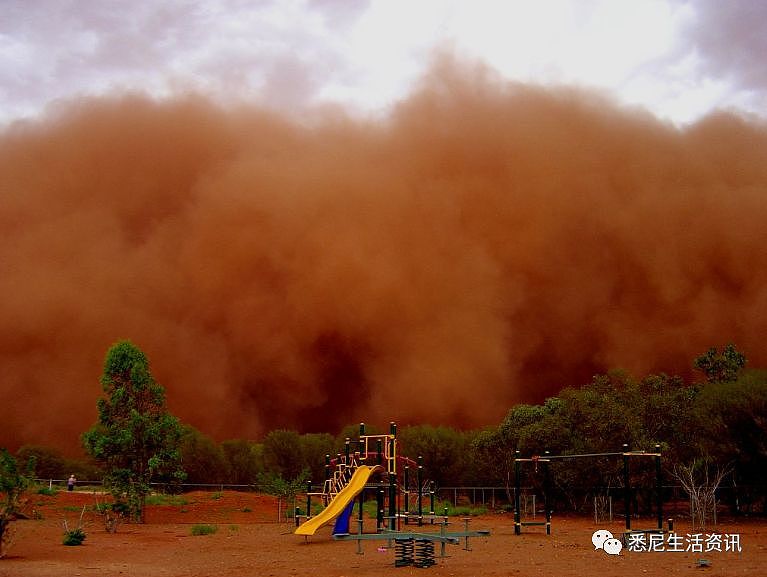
<box><xmin>514</xmin><ymin>443</ymin><xmax>663</xmax><ymax>536</ymax></box>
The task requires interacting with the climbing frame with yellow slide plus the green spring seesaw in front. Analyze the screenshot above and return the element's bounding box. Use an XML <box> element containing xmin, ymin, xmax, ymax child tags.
<box><xmin>294</xmin><ymin>422</ymin><xmax>490</xmax><ymax>567</ymax></box>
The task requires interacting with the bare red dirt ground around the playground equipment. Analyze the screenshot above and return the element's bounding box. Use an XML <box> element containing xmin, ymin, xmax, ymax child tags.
<box><xmin>0</xmin><ymin>491</ymin><xmax>767</xmax><ymax>577</ymax></box>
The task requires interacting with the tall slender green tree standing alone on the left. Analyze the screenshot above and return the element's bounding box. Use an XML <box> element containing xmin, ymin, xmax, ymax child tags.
<box><xmin>82</xmin><ymin>341</ymin><xmax>184</xmax><ymax>523</ymax></box>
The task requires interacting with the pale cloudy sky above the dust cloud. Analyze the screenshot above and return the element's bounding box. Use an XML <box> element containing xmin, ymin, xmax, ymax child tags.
<box><xmin>0</xmin><ymin>0</ymin><xmax>767</xmax><ymax>124</ymax></box>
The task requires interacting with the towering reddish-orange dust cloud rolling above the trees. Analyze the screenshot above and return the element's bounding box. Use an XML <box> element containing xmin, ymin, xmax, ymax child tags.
<box><xmin>0</xmin><ymin>67</ymin><xmax>767</xmax><ymax>448</ymax></box>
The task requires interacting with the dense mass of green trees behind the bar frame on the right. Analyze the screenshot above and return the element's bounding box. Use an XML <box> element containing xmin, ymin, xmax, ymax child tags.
<box><xmin>456</xmin><ymin>352</ymin><xmax>767</xmax><ymax>508</ymax></box>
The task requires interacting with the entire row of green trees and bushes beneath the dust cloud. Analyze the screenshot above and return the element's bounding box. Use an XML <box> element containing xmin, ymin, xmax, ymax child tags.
<box><xmin>3</xmin><ymin>341</ymin><xmax>767</xmax><ymax>520</ymax></box>
